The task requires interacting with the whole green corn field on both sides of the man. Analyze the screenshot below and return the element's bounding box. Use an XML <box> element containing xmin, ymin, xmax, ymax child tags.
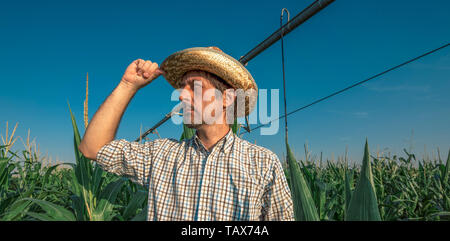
<box><xmin>0</xmin><ymin>106</ymin><xmax>450</xmax><ymax>221</ymax></box>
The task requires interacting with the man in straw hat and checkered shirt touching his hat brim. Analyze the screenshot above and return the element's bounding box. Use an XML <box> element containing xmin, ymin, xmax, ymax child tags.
<box><xmin>79</xmin><ymin>47</ymin><xmax>294</xmax><ymax>221</ymax></box>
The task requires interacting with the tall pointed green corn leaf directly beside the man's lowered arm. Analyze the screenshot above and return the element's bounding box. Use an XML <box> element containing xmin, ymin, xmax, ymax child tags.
<box><xmin>286</xmin><ymin>141</ymin><xmax>319</xmax><ymax>221</ymax></box>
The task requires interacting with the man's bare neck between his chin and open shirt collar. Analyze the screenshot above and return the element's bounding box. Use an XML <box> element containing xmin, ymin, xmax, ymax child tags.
<box><xmin>197</xmin><ymin>123</ymin><xmax>230</xmax><ymax>151</ymax></box>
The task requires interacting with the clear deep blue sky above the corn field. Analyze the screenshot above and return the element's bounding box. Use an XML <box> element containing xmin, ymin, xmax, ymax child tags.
<box><xmin>0</xmin><ymin>0</ymin><xmax>450</xmax><ymax>162</ymax></box>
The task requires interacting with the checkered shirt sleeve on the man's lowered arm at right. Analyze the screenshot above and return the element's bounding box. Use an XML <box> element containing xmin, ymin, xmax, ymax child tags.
<box><xmin>262</xmin><ymin>157</ymin><xmax>295</xmax><ymax>221</ymax></box>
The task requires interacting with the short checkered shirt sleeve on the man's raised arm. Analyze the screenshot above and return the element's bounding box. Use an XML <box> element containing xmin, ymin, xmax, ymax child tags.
<box><xmin>96</xmin><ymin>139</ymin><xmax>155</xmax><ymax>186</ymax></box>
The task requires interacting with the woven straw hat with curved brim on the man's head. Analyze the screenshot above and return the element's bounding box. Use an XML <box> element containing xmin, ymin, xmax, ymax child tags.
<box><xmin>161</xmin><ymin>47</ymin><xmax>258</xmax><ymax>117</ymax></box>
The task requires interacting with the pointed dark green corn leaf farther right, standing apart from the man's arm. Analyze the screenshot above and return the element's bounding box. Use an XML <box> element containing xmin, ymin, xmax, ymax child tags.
<box><xmin>345</xmin><ymin>139</ymin><xmax>381</xmax><ymax>221</ymax></box>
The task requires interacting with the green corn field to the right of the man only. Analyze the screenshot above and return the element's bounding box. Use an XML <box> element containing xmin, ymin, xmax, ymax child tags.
<box><xmin>285</xmin><ymin>142</ymin><xmax>450</xmax><ymax>221</ymax></box>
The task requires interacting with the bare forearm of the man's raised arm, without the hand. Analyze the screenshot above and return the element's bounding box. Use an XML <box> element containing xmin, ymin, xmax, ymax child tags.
<box><xmin>79</xmin><ymin>82</ymin><xmax>137</xmax><ymax>160</ymax></box>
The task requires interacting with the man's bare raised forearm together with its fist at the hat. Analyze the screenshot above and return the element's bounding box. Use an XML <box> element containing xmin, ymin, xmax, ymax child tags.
<box><xmin>78</xmin><ymin>59</ymin><xmax>163</xmax><ymax>160</ymax></box>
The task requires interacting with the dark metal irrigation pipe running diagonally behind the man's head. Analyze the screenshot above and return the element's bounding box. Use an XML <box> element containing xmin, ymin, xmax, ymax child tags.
<box><xmin>135</xmin><ymin>0</ymin><xmax>334</xmax><ymax>142</ymax></box>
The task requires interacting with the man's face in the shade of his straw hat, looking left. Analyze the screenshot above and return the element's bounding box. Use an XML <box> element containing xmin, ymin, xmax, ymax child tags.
<box><xmin>179</xmin><ymin>71</ymin><xmax>223</xmax><ymax>129</ymax></box>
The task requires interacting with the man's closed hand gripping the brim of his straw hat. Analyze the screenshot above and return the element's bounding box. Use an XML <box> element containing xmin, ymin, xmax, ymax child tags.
<box><xmin>121</xmin><ymin>59</ymin><xmax>163</xmax><ymax>90</ymax></box>
